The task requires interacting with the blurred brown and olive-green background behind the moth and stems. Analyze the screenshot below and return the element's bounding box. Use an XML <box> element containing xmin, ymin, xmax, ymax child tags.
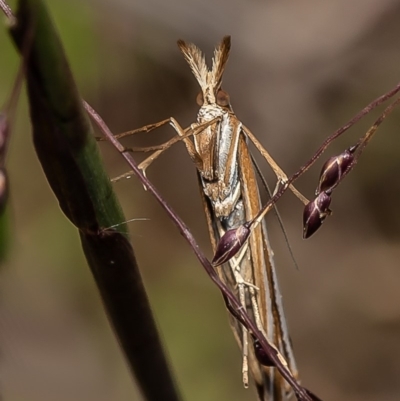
<box><xmin>0</xmin><ymin>0</ymin><xmax>400</xmax><ymax>401</ymax></box>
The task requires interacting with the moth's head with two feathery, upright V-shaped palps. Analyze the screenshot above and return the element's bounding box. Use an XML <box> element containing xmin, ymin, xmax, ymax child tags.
<box><xmin>178</xmin><ymin>36</ymin><xmax>231</xmax><ymax>109</ymax></box>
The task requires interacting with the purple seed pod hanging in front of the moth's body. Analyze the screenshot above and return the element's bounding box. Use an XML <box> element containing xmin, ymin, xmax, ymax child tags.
<box><xmin>211</xmin><ymin>224</ymin><xmax>250</xmax><ymax>266</ymax></box>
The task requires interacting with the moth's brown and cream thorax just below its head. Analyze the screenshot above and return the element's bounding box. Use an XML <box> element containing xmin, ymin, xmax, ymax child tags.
<box><xmin>194</xmin><ymin>104</ymin><xmax>240</xmax><ymax>217</ymax></box>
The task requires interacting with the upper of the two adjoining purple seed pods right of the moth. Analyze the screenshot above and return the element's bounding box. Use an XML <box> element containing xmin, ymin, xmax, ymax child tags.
<box><xmin>315</xmin><ymin>146</ymin><xmax>357</xmax><ymax>195</ymax></box>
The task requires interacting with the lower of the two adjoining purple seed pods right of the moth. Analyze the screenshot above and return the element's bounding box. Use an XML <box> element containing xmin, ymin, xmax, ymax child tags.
<box><xmin>303</xmin><ymin>191</ymin><xmax>331</xmax><ymax>239</ymax></box>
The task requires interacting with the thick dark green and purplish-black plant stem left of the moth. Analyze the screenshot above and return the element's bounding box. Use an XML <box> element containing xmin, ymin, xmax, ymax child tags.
<box><xmin>7</xmin><ymin>0</ymin><xmax>179</xmax><ymax>401</ymax></box>
